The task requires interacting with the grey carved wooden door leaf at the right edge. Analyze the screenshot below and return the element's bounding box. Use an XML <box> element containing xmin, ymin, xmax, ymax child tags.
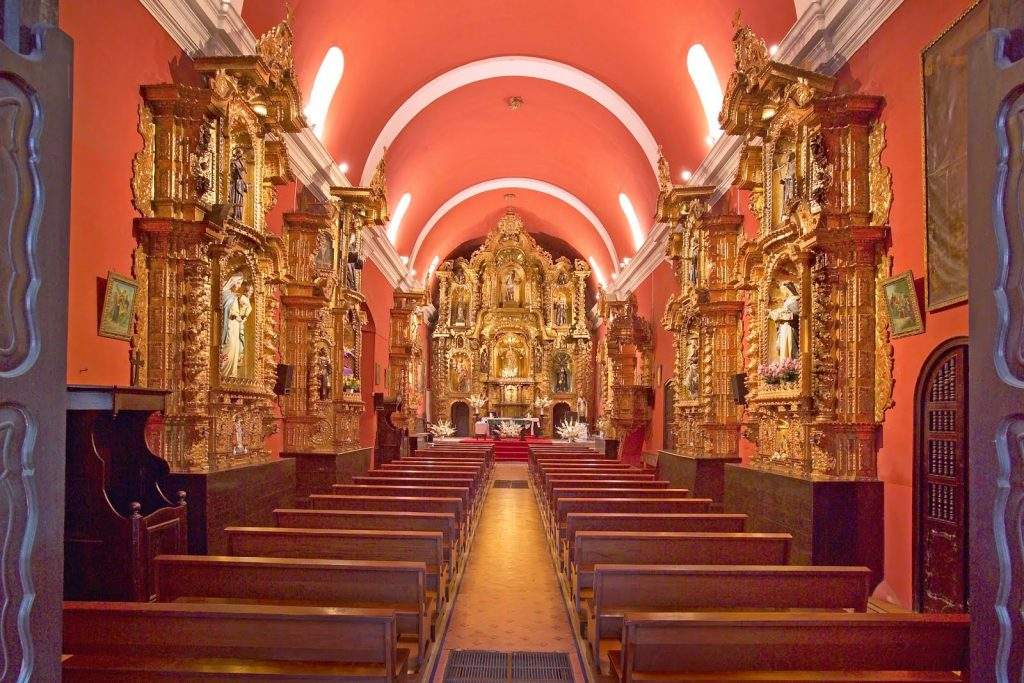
<box><xmin>968</xmin><ymin>20</ymin><xmax>1024</xmax><ymax>681</ymax></box>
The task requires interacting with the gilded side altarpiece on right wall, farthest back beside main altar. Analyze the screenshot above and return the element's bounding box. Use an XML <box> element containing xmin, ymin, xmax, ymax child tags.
<box><xmin>597</xmin><ymin>292</ymin><xmax>654</xmax><ymax>440</ymax></box>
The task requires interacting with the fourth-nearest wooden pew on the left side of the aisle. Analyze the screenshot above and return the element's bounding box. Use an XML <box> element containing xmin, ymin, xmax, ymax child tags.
<box><xmin>273</xmin><ymin>509</ymin><xmax>465</xmax><ymax>567</ymax></box>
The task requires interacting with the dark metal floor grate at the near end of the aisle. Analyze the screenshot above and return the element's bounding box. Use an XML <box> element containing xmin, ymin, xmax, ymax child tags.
<box><xmin>443</xmin><ymin>650</ymin><xmax>572</xmax><ymax>683</ymax></box>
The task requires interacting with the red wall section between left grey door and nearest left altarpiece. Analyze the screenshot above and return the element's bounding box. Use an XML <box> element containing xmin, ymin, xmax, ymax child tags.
<box><xmin>59</xmin><ymin>0</ymin><xmax>196</xmax><ymax>385</ymax></box>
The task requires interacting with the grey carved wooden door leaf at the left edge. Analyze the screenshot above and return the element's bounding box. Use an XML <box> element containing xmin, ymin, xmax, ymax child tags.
<box><xmin>0</xmin><ymin>0</ymin><xmax>72</xmax><ymax>681</ymax></box>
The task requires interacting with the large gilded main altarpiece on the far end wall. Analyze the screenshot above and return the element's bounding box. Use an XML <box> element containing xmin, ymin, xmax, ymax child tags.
<box><xmin>431</xmin><ymin>209</ymin><xmax>593</xmax><ymax>435</ymax></box>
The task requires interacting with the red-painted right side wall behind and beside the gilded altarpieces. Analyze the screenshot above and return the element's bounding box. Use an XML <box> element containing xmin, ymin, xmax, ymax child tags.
<box><xmin>637</xmin><ymin>0</ymin><xmax>973</xmax><ymax>607</ymax></box>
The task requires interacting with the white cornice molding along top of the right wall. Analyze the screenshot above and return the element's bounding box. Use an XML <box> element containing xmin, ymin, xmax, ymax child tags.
<box><xmin>607</xmin><ymin>0</ymin><xmax>903</xmax><ymax>299</ymax></box>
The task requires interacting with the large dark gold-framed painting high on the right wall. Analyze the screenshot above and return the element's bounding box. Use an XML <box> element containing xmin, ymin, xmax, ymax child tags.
<box><xmin>921</xmin><ymin>0</ymin><xmax>989</xmax><ymax>310</ymax></box>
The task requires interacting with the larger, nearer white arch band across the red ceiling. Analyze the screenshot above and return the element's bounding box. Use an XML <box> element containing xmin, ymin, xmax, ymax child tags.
<box><xmin>361</xmin><ymin>55</ymin><xmax>658</xmax><ymax>184</ymax></box>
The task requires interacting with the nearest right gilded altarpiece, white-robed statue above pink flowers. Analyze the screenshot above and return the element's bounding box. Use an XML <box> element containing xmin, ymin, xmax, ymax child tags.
<box><xmin>720</xmin><ymin>21</ymin><xmax>892</xmax><ymax>479</ymax></box>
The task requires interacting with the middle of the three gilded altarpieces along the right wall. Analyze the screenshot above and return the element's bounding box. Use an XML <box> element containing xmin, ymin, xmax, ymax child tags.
<box><xmin>658</xmin><ymin>186</ymin><xmax>743</xmax><ymax>457</ymax></box>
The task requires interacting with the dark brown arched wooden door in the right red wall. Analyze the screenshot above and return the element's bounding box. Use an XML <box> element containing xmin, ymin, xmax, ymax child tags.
<box><xmin>914</xmin><ymin>340</ymin><xmax>969</xmax><ymax>612</ymax></box>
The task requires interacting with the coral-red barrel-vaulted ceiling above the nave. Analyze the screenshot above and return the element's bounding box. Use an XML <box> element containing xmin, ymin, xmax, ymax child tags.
<box><xmin>243</xmin><ymin>0</ymin><xmax>796</xmax><ymax>278</ymax></box>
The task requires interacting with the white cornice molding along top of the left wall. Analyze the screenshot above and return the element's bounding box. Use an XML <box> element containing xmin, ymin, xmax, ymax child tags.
<box><xmin>139</xmin><ymin>0</ymin><xmax>409</xmax><ymax>288</ymax></box>
